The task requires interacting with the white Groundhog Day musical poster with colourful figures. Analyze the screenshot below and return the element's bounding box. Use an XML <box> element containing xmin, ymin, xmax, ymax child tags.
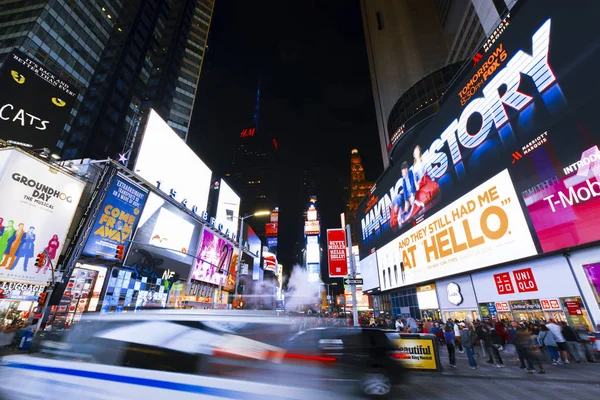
<box><xmin>0</xmin><ymin>149</ymin><xmax>85</xmax><ymax>285</ymax></box>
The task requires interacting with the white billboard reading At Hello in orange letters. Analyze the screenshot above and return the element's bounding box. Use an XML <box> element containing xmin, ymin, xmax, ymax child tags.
<box><xmin>377</xmin><ymin>171</ymin><xmax>536</xmax><ymax>290</ymax></box>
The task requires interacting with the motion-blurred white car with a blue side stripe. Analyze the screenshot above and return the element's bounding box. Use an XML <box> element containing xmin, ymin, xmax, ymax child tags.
<box><xmin>0</xmin><ymin>311</ymin><xmax>356</xmax><ymax>400</ymax></box>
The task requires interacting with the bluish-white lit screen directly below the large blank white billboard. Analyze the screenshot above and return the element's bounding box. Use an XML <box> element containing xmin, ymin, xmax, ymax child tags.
<box><xmin>125</xmin><ymin>192</ymin><xmax>202</xmax><ymax>280</ymax></box>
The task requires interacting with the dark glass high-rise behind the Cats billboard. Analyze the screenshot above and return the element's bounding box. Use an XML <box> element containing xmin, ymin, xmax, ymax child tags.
<box><xmin>0</xmin><ymin>0</ymin><xmax>214</xmax><ymax>158</ymax></box>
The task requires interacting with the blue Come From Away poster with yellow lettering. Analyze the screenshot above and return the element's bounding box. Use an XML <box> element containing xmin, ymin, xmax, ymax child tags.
<box><xmin>83</xmin><ymin>175</ymin><xmax>148</xmax><ymax>260</ymax></box>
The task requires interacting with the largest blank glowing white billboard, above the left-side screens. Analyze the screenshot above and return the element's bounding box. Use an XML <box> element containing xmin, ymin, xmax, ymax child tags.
<box><xmin>134</xmin><ymin>110</ymin><xmax>212</xmax><ymax>213</ymax></box>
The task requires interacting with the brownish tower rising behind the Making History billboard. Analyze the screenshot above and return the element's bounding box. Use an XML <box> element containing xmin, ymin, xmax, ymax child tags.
<box><xmin>361</xmin><ymin>0</ymin><xmax>516</xmax><ymax>166</ymax></box>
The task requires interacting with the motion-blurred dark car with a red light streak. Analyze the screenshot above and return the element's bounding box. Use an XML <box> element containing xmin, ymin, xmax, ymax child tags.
<box><xmin>283</xmin><ymin>327</ymin><xmax>404</xmax><ymax>397</ymax></box>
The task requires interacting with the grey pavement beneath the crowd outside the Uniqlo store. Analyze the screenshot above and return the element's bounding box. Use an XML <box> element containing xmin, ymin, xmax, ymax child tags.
<box><xmin>434</xmin><ymin>346</ymin><xmax>600</xmax><ymax>384</ymax></box>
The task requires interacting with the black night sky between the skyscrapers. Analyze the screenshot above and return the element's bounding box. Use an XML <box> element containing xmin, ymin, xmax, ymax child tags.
<box><xmin>188</xmin><ymin>0</ymin><xmax>383</xmax><ymax>271</ymax></box>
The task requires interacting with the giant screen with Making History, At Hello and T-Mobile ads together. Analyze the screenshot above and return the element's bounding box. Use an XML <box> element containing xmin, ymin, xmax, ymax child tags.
<box><xmin>357</xmin><ymin>0</ymin><xmax>600</xmax><ymax>278</ymax></box>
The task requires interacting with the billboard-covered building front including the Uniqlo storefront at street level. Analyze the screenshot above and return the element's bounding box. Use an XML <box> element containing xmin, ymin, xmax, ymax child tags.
<box><xmin>356</xmin><ymin>0</ymin><xmax>600</xmax><ymax>331</ymax></box>
